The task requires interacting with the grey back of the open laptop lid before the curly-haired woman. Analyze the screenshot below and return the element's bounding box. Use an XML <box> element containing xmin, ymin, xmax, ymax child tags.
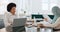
<box><xmin>13</xmin><ymin>18</ymin><xmax>27</xmax><ymax>27</ymax></box>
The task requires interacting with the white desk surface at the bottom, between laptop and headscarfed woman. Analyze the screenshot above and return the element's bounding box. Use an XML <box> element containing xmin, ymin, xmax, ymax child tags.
<box><xmin>25</xmin><ymin>27</ymin><xmax>53</xmax><ymax>32</ymax></box>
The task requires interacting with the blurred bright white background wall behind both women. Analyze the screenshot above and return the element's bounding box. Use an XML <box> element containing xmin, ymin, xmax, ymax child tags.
<box><xmin>0</xmin><ymin>0</ymin><xmax>60</xmax><ymax>31</ymax></box>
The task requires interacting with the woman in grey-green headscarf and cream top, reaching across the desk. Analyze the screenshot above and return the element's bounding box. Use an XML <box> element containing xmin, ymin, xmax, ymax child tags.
<box><xmin>38</xmin><ymin>6</ymin><xmax>60</xmax><ymax>32</ymax></box>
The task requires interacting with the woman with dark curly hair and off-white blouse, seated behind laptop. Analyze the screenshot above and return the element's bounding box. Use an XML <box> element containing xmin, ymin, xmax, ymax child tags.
<box><xmin>4</xmin><ymin>3</ymin><xmax>16</xmax><ymax>32</ymax></box>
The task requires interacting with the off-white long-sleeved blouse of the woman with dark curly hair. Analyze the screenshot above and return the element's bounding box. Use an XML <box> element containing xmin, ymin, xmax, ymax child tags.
<box><xmin>4</xmin><ymin>12</ymin><xmax>16</xmax><ymax>27</ymax></box>
